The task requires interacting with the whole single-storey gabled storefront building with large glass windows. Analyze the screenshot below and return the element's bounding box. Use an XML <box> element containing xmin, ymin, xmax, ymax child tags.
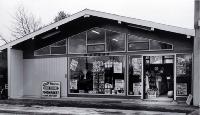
<box><xmin>0</xmin><ymin>10</ymin><xmax>198</xmax><ymax>106</ymax></box>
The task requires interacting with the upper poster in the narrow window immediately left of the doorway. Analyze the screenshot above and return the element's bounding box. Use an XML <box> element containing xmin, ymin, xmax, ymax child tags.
<box><xmin>132</xmin><ymin>58</ymin><xmax>142</xmax><ymax>75</ymax></box>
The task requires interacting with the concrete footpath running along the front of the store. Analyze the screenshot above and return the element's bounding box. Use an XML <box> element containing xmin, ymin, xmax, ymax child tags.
<box><xmin>0</xmin><ymin>97</ymin><xmax>200</xmax><ymax>115</ymax></box>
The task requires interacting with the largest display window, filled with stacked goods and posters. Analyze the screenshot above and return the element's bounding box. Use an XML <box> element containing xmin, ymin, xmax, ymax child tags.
<box><xmin>69</xmin><ymin>56</ymin><xmax>125</xmax><ymax>95</ymax></box>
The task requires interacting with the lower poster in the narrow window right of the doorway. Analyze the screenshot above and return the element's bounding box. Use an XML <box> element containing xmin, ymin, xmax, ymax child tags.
<box><xmin>176</xmin><ymin>83</ymin><xmax>187</xmax><ymax>95</ymax></box>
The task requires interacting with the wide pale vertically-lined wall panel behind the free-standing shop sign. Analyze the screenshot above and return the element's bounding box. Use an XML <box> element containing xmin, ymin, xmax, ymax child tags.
<box><xmin>24</xmin><ymin>57</ymin><xmax>67</xmax><ymax>98</ymax></box>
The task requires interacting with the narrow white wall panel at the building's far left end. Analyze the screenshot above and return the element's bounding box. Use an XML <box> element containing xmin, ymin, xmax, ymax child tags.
<box><xmin>8</xmin><ymin>49</ymin><xmax>23</xmax><ymax>98</ymax></box>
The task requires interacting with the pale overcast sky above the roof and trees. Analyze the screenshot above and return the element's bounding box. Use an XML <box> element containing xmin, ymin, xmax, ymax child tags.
<box><xmin>0</xmin><ymin>0</ymin><xmax>194</xmax><ymax>45</ymax></box>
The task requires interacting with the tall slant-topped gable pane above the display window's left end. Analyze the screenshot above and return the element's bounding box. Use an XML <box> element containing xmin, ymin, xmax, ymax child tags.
<box><xmin>69</xmin><ymin>32</ymin><xmax>86</xmax><ymax>54</ymax></box>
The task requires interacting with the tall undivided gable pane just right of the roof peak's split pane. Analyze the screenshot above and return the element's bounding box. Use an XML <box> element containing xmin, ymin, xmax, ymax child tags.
<box><xmin>106</xmin><ymin>30</ymin><xmax>126</xmax><ymax>51</ymax></box>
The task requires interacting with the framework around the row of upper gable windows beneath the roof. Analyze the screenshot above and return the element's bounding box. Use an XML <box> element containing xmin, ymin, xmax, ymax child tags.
<box><xmin>34</xmin><ymin>27</ymin><xmax>174</xmax><ymax>56</ymax></box>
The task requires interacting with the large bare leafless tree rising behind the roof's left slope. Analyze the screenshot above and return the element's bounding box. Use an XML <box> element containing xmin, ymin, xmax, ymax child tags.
<box><xmin>11</xmin><ymin>5</ymin><xmax>41</xmax><ymax>38</ymax></box>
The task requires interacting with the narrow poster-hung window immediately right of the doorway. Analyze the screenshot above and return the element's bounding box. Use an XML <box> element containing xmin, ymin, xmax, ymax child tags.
<box><xmin>176</xmin><ymin>54</ymin><xmax>192</xmax><ymax>96</ymax></box>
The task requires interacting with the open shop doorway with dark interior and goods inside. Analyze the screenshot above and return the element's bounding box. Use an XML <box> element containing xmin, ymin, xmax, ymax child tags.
<box><xmin>143</xmin><ymin>55</ymin><xmax>174</xmax><ymax>101</ymax></box>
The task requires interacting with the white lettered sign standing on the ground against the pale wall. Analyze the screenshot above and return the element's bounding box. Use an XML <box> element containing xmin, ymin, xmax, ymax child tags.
<box><xmin>42</xmin><ymin>81</ymin><xmax>60</xmax><ymax>98</ymax></box>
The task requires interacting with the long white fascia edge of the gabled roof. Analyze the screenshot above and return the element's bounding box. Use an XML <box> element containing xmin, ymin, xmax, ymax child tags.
<box><xmin>0</xmin><ymin>9</ymin><xmax>195</xmax><ymax>50</ymax></box>
